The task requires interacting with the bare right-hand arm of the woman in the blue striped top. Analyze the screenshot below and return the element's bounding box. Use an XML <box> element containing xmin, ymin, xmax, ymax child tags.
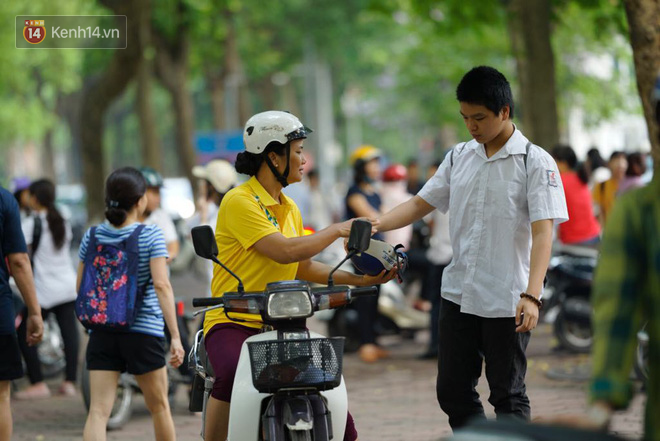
<box><xmin>149</xmin><ymin>257</ymin><xmax>185</xmax><ymax>367</ymax></box>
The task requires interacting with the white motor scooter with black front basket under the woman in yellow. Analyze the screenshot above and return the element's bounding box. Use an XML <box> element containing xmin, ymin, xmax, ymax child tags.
<box><xmin>189</xmin><ymin>220</ymin><xmax>376</xmax><ymax>441</ymax></box>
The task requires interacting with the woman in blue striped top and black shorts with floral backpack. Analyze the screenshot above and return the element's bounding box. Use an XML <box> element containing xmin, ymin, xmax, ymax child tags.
<box><xmin>76</xmin><ymin>167</ymin><xmax>184</xmax><ymax>441</ymax></box>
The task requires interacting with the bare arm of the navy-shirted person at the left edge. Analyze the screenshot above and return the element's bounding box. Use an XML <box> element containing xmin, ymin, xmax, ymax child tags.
<box><xmin>7</xmin><ymin>253</ymin><xmax>44</xmax><ymax>346</ymax></box>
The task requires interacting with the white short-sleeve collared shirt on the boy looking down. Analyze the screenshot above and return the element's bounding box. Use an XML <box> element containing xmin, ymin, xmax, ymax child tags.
<box><xmin>418</xmin><ymin>129</ymin><xmax>568</xmax><ymax>318</ymax></box>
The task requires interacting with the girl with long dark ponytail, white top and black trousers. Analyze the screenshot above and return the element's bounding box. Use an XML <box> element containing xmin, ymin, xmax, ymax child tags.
<box><xmin>16</xmin><ymin>179</ymin><xmax>80</xmax><ymax>400</ymax></box>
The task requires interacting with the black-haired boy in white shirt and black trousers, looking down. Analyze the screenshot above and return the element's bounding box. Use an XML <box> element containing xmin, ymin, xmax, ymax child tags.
<box><xmin>378</xmin><ymin>66</ymin><xmax>568</xmax><ymax>429</ymax></box>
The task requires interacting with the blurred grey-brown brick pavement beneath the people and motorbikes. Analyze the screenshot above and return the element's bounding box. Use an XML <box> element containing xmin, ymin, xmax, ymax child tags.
<box><xmin>12</xmin><ymin>324</ymin><xmax>644</xmax><ymax>441</ymax></box>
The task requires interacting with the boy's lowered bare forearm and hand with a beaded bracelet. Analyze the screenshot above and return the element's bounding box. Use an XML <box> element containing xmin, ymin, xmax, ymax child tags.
<box><xmin>516</xmin><ymin>219</ymin><xmax>552</xmax><ymax>332</ymax></box>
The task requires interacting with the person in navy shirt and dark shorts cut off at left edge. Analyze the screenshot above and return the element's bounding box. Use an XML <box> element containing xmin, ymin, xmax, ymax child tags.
<box><xmin>0</xmin><ymin>187</ymin><xmax>44</xmax><ymax>441</ymax></box>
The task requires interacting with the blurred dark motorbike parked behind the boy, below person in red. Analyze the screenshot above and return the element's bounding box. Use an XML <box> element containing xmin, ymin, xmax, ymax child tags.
<box><xmin>543</xmin><ymin>245</ymin><xmax>598</xmax><ymax>353</ymax></box>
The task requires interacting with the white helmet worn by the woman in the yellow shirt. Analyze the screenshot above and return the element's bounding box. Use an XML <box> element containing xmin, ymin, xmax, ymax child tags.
<box><xmin>243</xmin><ymin>110</ymin><xmax>311</xmax><ymax>154</ymax></box>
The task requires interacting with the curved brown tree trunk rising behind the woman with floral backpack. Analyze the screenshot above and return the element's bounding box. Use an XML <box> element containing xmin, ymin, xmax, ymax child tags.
<box><xmin>79</xmin><ymin>0</ymin><xmax>150</xmax><ymax>223</ymax></box>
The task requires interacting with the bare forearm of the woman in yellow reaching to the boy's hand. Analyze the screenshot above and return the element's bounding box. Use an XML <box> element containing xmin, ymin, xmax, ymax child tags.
<box><xmin>254</xmin><ymin>220</ymin><xmax>353</xmax><ymax>264</ymax></box>
